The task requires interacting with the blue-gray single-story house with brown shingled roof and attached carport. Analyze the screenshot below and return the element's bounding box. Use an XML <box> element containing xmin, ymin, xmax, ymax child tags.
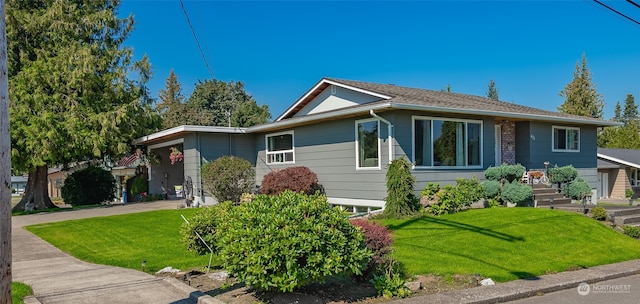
<box><xmin>136</xmin><ymin>78</ymin><xmax>618</xmax><ymax>210</ymax></box>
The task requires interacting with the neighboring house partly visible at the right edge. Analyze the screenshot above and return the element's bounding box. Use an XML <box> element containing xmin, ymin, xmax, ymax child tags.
<box><xmin>598</xmin><ymin>148</ymin><xmax>640</xmax><ymax>199</ymax></box>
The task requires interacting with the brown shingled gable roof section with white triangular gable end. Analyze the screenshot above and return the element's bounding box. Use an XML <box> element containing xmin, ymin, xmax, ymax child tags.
<box><xmin>274</xmin><ymin>78</ymin><xmax>620</xmax><ymax>126</ymax></box>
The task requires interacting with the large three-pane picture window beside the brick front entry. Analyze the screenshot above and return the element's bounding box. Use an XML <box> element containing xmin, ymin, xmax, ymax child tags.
<box><xmin>413</xmin><ymin>117</ymin><xmax>482</xmax><ymax>167</ymax></box>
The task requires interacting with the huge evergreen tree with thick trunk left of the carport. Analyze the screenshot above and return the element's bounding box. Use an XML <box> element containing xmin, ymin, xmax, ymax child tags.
<box><xmin>5</xmin><ymin>0</ymin><xmax>159</xmax><ymax>210</ymax></box>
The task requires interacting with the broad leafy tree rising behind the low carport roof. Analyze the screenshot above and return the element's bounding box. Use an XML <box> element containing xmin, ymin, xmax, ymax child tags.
<box><xmin>184</xmin><ymin>79</ymin><xmax>271</xmax><ymax>127</ymax></box>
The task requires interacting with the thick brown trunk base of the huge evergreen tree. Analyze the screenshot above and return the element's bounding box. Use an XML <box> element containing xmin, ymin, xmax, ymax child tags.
<box><xmin>13</xmin><ymin>165</ymin><xmax>57</xmax><ymax>211</ymax></box>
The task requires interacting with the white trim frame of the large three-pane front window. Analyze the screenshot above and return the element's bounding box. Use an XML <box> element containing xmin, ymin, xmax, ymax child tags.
<box><xmin>411</xmin><ymin>116</ymin><xmax>484</xmax><ymax>170</ymax></box>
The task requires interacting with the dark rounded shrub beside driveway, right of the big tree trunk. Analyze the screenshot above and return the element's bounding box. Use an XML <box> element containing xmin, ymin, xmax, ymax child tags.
<box><xmin>60</xmin><ymin>166</ymin><xmax>116</xmax><ymax>206</ymax></box>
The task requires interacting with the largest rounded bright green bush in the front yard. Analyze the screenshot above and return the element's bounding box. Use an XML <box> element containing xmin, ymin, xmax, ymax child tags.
<box><xmin>218</xmin><ymin>191</ymin><xmax>371</xmax><ymax>292</ymax></box>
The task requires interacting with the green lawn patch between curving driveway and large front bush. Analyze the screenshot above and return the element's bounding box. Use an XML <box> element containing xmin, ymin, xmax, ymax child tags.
<box><xmin>26</xmin><ymin>209</ymin><xmax>216</xmax><ymax>272</ymax></box>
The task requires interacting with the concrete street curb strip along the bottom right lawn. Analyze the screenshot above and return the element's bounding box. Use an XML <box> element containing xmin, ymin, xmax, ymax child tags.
<box><xmin>390</xmin><ymin>260</ymin><xmax>640</xmax><ymax>304</ymax></box>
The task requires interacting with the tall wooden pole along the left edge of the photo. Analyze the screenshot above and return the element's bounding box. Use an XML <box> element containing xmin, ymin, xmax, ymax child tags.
<box><xmin>0</xmin><ymin>0</ymin><xmax>12</xmax><ymax>304</ymax></box>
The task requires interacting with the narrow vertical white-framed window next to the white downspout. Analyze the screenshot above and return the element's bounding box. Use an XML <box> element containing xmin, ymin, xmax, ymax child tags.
<box><xmin>356</xmin><ymin>119</ymin><xmax>380</xmax><ymax>169</ymax></box>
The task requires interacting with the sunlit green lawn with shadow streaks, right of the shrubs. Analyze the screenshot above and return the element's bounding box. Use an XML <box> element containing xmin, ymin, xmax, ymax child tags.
<box><xmin>383</xmin><ymin>208</ymin><xmax>640</xmax><ymax>281</ymax></box>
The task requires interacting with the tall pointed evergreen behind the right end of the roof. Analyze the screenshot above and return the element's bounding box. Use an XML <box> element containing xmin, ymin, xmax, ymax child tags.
<box><xmin>558</xmin><ymin>54</ymin><xmax>604</xmax><ymax>118</ymax></box>
